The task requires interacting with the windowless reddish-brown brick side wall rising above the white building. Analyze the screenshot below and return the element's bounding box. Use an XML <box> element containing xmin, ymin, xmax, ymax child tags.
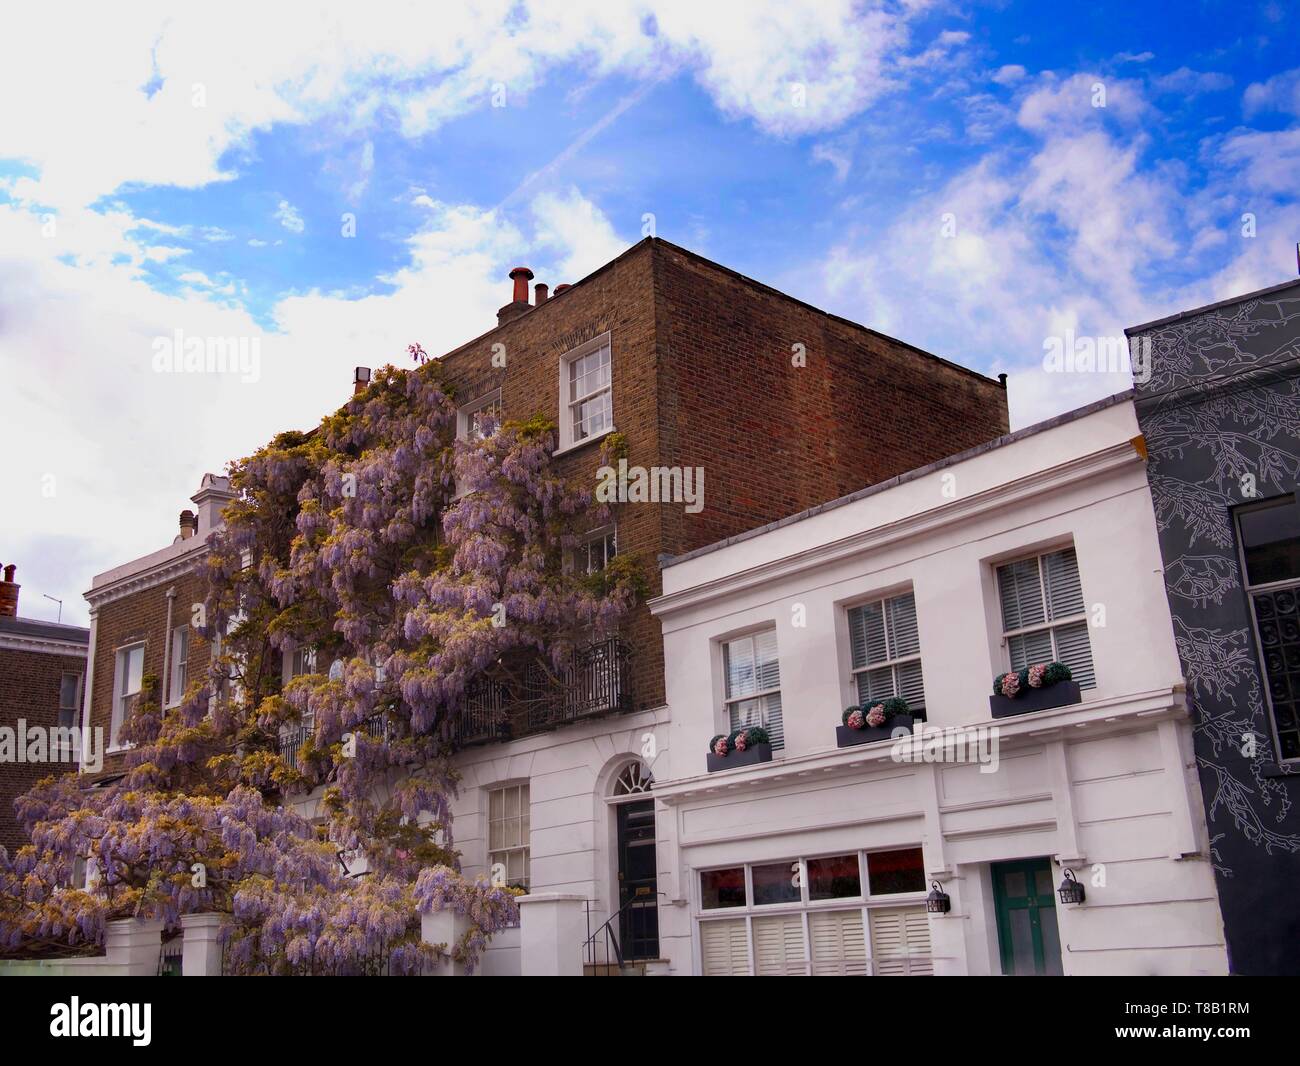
<box><xmin>657</xmin><ymin>243</ymin><xmax>1008</xmax><ymax>555</ymax></box>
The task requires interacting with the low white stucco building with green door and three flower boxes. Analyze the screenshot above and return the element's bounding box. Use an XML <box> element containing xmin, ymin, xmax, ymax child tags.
<box><xmin>650</xmin><ymin>398</ymin><xmax>1227</xmax><ymax>975</ymax></box>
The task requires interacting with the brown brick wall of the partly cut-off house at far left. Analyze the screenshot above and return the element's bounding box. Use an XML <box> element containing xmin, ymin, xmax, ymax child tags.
<box><xmin>0</xmin><ymin>649</ymin><xmax>86</xmax><ymax>855</ymax></box>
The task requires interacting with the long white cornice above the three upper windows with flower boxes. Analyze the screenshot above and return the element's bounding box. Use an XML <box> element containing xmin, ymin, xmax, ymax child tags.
<box><xmin>649</xmin><ymin>441</ymin><xmax>1141</xmax><ymax>618</ymax></box>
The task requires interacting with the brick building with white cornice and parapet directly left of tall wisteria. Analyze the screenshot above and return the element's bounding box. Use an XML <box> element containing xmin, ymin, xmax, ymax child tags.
<box><xmin>85</xmin><ymin>473</ymin><xmax>234</xmax><ymax>772</ymax></box>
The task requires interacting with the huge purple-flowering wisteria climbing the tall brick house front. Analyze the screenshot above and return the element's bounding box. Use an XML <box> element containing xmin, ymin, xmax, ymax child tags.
<box><xmin>0</xmin><ymin>361</ymin><xmax>644</xmax><ymax>972</ymax></box>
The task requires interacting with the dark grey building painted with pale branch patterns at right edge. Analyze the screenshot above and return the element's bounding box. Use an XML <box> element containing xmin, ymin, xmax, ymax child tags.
<box><xmin>1127</xmin><ymin>281</ymin><xmax>1300</xmax><ymax>975</ymax></box>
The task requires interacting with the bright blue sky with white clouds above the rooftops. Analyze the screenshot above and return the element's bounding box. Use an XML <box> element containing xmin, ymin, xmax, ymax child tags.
<box><xmin>0</xmin><ymin>0</ymin><xmax>1300</xmax><ymax>624</ymax></box>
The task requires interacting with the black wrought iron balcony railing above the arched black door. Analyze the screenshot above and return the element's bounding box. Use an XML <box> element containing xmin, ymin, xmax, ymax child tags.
<box><xmin>454</xmin><ymin>637</ymin><xmax>632</xmax><ymax>746</ymax></box>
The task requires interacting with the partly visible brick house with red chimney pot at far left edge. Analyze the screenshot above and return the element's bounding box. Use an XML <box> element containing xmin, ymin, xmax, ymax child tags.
<box><xmin>0</xmin><ymin>564</ymin><xmax>90</xmax><ymax>854</ymax></box>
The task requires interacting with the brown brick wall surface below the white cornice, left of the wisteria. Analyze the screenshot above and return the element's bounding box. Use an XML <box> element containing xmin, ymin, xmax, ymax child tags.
<box><xmin>90</xmin><ymin>573</ymin><xmax>208</xmax><ymax>771</ymax></box>
